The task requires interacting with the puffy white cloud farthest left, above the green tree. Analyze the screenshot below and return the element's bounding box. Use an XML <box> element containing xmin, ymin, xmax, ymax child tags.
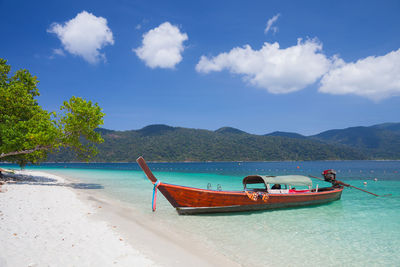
<box><xmin>47</xmin><ymin>11</ymin><xmax>114</xmax><ymax>64</ymax></box>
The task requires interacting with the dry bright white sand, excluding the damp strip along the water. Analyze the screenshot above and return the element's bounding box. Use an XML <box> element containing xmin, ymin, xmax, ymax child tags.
<box><xmin>0</xmin><ymin>173</ymin><xmax>154</xmax><ymax>266</ymax></box>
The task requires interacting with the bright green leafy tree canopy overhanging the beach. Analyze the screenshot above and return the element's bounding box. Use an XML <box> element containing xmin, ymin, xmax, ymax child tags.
<box><xmin>0</xmin><ymin>58</ymin><xmax>104</xmax><ymax>166</ymax></box>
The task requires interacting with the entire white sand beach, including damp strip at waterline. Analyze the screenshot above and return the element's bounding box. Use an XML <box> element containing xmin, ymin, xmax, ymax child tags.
<box><xmin>0</xmin><ymin>171</ymin><xmax>237</xmax><ymax>267</ymax></box>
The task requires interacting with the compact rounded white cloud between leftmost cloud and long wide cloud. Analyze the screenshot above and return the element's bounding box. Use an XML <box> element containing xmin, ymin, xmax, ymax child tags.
<box><xmin>133</xmin><ymin>22</ymin><xmax>188</xmax><ymax>68</ymax></box>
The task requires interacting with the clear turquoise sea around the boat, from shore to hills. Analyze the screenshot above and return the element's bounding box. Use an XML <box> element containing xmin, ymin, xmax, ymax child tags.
<box><xmin>0</xmin><ymin>161</ymin><xmax>400</xmax><ymax>266</ymax></box>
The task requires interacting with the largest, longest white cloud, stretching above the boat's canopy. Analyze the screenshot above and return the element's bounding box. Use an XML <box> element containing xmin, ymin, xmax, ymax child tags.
<box><xmin>196</xmin><ymin>39</ymin><xmax>334</xmax><ymax>94</ymax></box>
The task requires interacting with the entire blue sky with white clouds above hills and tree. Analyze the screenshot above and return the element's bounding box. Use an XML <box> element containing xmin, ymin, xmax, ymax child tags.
<box><xmin>0</xmin><ymin>0</ymin><xmax>400</xmax><ymax>135</ymax></box>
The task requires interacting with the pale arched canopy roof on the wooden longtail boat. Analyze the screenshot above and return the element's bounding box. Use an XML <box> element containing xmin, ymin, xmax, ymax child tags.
<box><xmin>243</xmin><ymin>175</ymin><xmax>312</xmax><ymax>186</ymax></box>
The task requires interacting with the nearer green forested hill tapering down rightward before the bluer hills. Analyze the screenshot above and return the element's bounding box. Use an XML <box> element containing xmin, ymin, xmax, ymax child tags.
<box><xmin>48</xmin><ymin>125</ymin><xmax>367</xmax><ymax>162</ymax></box>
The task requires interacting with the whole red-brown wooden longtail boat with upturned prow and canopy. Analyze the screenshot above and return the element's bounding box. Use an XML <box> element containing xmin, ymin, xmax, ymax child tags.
<box><xmin>136</xmin><ymin>157</ymin><xmax>343</xmax><ymax>214</ymax></box>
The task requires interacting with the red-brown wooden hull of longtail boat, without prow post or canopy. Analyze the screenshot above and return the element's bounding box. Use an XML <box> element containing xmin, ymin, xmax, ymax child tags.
<box><xmin>158</xmin><ymin>183</ymin><xmax>343</xmax><ymax>214</ymax></box>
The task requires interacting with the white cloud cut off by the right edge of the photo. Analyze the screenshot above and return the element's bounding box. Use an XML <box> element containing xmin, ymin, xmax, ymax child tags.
<box><xmin>319</xmin><ymin>49</ymin><xmax>400</xmax><ymax>101</ymax></box>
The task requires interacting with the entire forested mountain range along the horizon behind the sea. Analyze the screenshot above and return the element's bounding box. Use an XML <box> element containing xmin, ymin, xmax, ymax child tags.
<box><xmin>48</xmin><ymin>123</ymin><xmax>400</xmax><ymax>162</ymax></box>
